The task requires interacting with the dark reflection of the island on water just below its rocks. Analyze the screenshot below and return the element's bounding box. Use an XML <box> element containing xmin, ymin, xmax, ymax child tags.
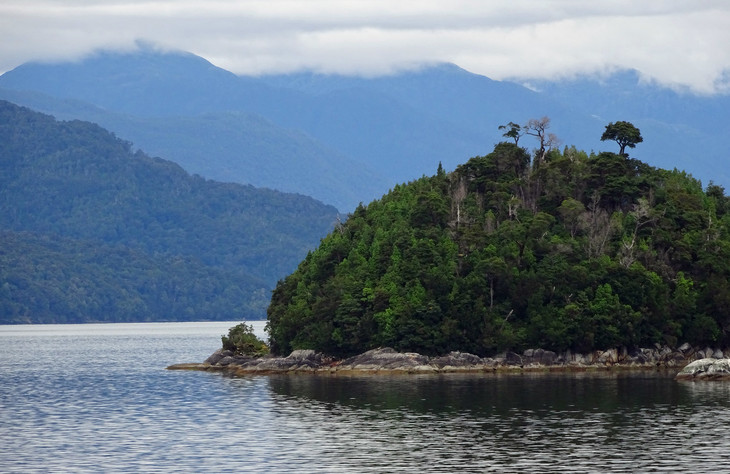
<box><xmin>268</xmin><ymin>372</ymin><xmax>688</xmax><ymax>415</ymax></box>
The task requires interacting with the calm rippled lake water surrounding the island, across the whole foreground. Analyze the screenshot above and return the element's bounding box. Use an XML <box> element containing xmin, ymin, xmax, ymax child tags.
<box><xmin>0</xmin><ymin>323</ymin><xmax>730</xmax><ymax>473</ymax></box>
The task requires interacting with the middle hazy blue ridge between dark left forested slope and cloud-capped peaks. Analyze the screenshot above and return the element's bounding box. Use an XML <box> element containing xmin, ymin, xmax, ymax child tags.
<box><xmin>0</xmin><ymin>89</ymin><xmax>387</xmax><ymax>209</ymax></box>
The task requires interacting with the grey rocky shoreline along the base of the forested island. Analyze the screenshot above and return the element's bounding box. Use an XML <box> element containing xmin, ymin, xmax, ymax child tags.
<box><xmin>167</xmin><ymin>344</ymin><xmax>730</xmax><ymax>380</ymax></box>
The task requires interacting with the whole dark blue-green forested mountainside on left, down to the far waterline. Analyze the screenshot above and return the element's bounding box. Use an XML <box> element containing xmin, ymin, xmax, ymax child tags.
<box><xmin>0</xmin><ymin>101</ymin><xmax>338</xmax><ymax>322</ymax></box>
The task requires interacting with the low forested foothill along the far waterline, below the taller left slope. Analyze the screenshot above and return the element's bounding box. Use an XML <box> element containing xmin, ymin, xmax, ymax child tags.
<box><xmin>0</xmin><ymin>231</ymin><xmax>269</xmax><ymax>323</ymax></box>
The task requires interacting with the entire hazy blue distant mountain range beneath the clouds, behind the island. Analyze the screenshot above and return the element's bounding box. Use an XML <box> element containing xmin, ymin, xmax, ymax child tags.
<box><xmin>0</xmin><ymin>45</ymin><xmax>730</xmax><ymax>211</ymax></box>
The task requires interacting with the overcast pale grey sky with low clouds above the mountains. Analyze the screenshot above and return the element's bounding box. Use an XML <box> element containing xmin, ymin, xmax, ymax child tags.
<box><xmin>0</xmin><ymin>0</ymin><xmax>730</xmax><ymax>93</ymax></box>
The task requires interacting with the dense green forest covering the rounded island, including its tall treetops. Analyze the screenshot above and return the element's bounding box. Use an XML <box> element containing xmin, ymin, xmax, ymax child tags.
<box><xmin>268</xmin><ymin>121</ymin><xmax>730</xmax><ymax>356</ymax></box>
